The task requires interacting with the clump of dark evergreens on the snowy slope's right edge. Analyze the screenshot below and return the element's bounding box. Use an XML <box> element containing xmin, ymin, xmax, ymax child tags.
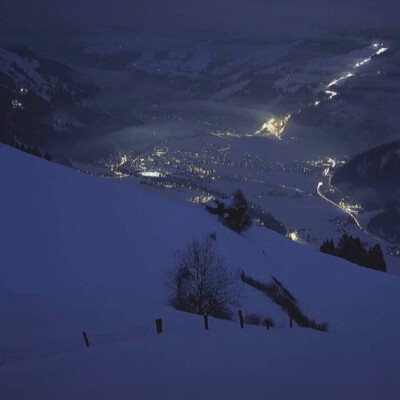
<box><xmin>320</xmin><ymin>234</ymin><xmax>386</xmax><ymax>272</ymax></box>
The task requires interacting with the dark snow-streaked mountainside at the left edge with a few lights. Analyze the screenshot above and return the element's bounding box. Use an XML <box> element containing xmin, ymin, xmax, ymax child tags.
<box><xmin>0</xmin><ymin>48</ymin><xmax>98</xmax><ymax>145</ymax></box>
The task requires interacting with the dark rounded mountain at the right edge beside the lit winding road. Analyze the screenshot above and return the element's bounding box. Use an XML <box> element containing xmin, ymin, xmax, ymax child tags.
<box><xmin>332</xmin><ymin>141</ymin><xmax>400</xmax><ymax>209</ymax></box>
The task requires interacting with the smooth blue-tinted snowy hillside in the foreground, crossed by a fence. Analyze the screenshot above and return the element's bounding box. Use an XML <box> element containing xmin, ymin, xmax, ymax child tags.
<box><xmin>0</xmin><ymin>145</ymin><xmax>400</xmax><ymax>400</ymax></box>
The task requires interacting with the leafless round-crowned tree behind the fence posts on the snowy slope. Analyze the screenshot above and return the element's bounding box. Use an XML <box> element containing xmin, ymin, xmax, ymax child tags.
<box><xmin>166</xmin><ymin>236</ymin><xmax>240</xmax><ymax>318</ymax></box>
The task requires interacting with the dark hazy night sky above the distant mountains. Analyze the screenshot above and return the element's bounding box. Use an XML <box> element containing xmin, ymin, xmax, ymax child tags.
<box><xmin>0</xmin><ymin>0</ymin><xmax>400</xmax><ymax>35</ymax></box>
